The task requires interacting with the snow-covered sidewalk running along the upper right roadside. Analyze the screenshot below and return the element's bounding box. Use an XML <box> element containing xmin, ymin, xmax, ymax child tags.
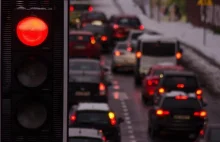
<box><xmin>117</xmin><ymin>0</ymin><xmax>220</xmax><ymax>65</ymax></box>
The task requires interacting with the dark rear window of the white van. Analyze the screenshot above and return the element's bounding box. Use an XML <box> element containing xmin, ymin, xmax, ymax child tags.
<box><xmin>142</xmin><ymin>42</ymin><xmax>176</xmax><ymax>57</ymax></box>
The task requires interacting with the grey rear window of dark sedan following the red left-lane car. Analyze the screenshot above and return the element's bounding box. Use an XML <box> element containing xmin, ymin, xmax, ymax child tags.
<box><xmin>69</xmin><ymin>61</ymin><xmax>100</xmax><ymax>71</ymax></box>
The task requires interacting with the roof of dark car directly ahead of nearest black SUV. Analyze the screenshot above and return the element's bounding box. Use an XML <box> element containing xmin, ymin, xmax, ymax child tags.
<box><xmin>163</xmin><ymin>70</ymin><xmax>195</xmax><ymax>76</ymax></box>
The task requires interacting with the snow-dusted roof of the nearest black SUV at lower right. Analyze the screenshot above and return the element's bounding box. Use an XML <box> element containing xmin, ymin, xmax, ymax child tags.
<box><xmin>162</xmin><ymin>91</ymin><xmax>196</xmax><ymax>99</ymax></box>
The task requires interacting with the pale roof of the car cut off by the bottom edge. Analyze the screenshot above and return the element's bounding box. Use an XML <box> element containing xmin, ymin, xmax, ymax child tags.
<box><xmin>69</xmin><ymin>128</ymin><xmax>103</xmax><ymax>138</ymax></box>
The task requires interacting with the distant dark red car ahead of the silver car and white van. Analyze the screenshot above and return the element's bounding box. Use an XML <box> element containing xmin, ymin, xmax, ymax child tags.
<box><xmin>109</xmin><ymin>15</ymin><xmax>144</xmax><ymax>41</ymax></box>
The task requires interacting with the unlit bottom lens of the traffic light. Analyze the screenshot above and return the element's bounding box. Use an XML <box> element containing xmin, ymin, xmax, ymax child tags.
<box><xmin>17</xmin><ymin>103</ymin><xmax>47</xmax><ymax>129</ymax></box>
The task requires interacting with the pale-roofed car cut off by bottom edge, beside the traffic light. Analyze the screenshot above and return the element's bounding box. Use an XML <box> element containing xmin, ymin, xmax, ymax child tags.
<box><xmin>68</xmin><ymin>128</ymin><xmax>106</xmax><ymax>142</ymax></box>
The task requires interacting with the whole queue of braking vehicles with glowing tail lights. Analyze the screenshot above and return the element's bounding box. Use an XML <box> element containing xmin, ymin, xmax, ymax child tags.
<box><xmin>68</xmin><ymin>1</ymin><xmax>218</xmax><ymax>142</ymax></box>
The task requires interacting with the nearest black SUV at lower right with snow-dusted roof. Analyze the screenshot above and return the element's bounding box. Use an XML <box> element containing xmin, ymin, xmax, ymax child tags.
<box><xmin>148</xmin><ymin>91</ymin><xmax>208</xmax><ymax>140</ymax></box>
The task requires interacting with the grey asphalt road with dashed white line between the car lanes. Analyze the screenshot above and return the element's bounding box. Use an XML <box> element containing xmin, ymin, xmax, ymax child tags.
<box><xmin>102</xmin><ymin>55</ymin><xmax>220</xmax><ymax>142</ymax></box>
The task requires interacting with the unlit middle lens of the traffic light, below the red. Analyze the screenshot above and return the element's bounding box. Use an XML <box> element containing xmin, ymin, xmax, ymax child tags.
<box><xmin>17</xmin><ymin>60</ymin><xmax>48</xmax><ymax>88</ymax></box>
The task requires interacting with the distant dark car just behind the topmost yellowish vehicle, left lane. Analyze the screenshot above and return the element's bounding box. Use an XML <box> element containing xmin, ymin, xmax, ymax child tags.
<box><xmin>80</xmin><ymin>11</ymin><xmax>108</xmax><ymax>27</ymax></box>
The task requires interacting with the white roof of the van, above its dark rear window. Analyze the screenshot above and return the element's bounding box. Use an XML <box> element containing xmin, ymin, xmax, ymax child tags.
<box><xmin>138</xmin><ymin>33</ymin><xmax>177</xmax><ymax>43</ymax></box>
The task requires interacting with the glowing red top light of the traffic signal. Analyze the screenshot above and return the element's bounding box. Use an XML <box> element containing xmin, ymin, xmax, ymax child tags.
<box><xmin>16</xmin><ymin>16</ymin><xmax>48</xmax><ymax>47</ymax></box>
